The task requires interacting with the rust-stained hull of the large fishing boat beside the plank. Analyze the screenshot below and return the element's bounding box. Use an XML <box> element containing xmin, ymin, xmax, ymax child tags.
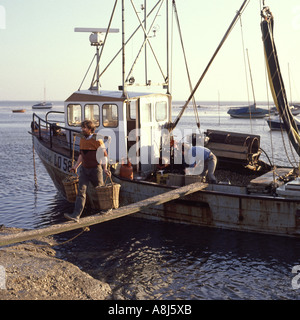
<box><xmin>33</xmin><ymin>136</ymin><xmax>300</xmax><ymax>236</ymax></box>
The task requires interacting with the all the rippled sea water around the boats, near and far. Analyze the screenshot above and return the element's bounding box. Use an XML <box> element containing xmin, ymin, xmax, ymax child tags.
<box><xmin>0</xmin><ymin>102</ymin><xmax>300</xmax><ymax>300</ymax></box>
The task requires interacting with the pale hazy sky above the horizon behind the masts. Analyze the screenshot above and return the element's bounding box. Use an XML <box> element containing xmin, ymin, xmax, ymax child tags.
<box><xmin>0</xmin><ymin>0</ymin><xmax>300</xmax><ymax>102</ymax></box>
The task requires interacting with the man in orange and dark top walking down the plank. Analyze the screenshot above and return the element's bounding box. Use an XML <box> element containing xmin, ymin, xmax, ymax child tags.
<box><xmin>64</xmin><ymin>120</ymin><xmax>110</xmax><ymax>222</ymax></box>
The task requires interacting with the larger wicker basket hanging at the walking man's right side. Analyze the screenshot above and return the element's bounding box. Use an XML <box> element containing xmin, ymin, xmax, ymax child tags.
<box><xmin>95</xmin><ymin>176</ymin><xmax>121</xmax><ymax>210</ymax></box>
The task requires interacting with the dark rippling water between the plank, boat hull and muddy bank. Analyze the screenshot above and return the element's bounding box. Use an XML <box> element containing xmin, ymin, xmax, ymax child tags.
<box><xmin>57</xmin><ymin>217</ymin><xmax>300</xmax><ymax>299</ymax></box>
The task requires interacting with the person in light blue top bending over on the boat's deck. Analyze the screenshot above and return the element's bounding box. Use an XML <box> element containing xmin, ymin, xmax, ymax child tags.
<box><xmin>182</xmin><ymin>144</ymin><xmax>217</xmax><ymax>183</ymax></box>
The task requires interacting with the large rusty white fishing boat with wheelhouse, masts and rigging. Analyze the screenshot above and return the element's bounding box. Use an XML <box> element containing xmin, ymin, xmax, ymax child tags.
<box><xmin>31</xmin><ymin>0</ymin><xmax>300</xmax><ymax>237</ymax></box>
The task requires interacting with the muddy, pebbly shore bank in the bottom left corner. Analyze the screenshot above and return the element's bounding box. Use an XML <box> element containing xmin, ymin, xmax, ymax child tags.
<box><xmin>0</xmin><ymin>227</ymin><xmax>112</xmax><ymax>300</ymax></box>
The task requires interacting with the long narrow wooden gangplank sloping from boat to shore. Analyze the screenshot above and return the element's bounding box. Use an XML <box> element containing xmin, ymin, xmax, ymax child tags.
<box><xmin>0</xmin><ymin>182</ymin><xmax>207</xmax><ymax>246</ymax></box>
